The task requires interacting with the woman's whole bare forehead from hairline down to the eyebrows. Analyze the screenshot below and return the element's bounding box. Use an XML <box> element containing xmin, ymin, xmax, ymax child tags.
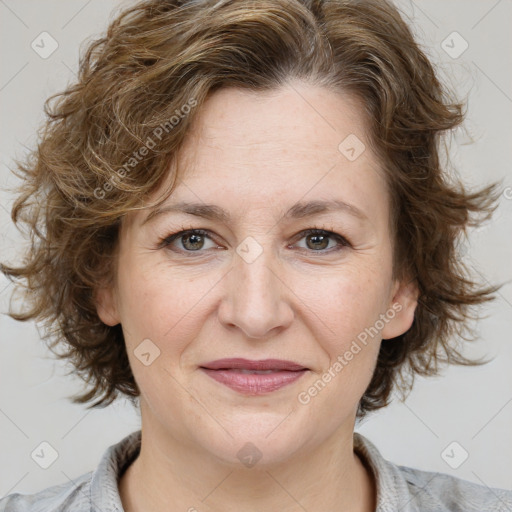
<box><xmin>144</xmin><ymin>82</ymin><xmax>387</xmax><ymax>228</ymax></box>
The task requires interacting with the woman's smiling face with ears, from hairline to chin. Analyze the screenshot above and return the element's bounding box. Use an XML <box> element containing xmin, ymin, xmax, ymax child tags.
<box><xmin>98</xmin><ymin>82</ymin><xmax>415</xmax><ymax>464</ymax></box>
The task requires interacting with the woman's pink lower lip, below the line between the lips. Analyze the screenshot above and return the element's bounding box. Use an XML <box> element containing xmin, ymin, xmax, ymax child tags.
<box><xmin>201</xmin><ymin>368</ymin><xmax>307</xmax><ymax>395</ymax></box>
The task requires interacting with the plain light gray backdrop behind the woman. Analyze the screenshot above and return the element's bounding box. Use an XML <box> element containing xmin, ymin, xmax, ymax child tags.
<box><xmin>0</xmin><ymin>0</ymin><xmax>512</xmax><ymax>496</ymax></box>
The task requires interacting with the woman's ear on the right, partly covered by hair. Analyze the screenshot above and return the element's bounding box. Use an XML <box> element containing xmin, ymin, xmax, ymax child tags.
<box><xmin>382</xmin><ymin>279</ymin><xmax>419</xmax><ymax>340</ymax></box>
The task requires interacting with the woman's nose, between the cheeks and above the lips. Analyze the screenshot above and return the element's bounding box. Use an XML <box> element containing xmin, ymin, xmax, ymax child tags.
<box><xmin>218</xmin><ymin>245</ymin><xmax>294</xmax><ymax>339</ymax></box>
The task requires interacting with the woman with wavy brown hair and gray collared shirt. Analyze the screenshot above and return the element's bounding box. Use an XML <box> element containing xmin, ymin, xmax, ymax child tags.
<box><xmin>0</xmin><ymin>0</ymin><xmax>512</xmax><ymax>512</ymax></box>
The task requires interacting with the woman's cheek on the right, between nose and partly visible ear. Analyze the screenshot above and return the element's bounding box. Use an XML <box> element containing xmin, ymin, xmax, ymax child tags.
<box><xmin>301</xmin><ymin>271</ymin><xmax>385</xmax><ymax>412</ymax></box>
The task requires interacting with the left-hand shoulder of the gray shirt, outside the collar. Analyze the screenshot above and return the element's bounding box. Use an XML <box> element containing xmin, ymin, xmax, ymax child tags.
<box><xmin>0</xmin><ymin>471</ymin><xmax>92</xmax><ymax>512</ymax></box>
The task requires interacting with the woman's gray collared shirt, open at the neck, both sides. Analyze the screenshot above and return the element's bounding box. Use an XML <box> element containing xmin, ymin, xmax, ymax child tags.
<box><xmin>0</xmin><ymin>431</ymin><xmax>512</xmax><ymax>512</ymax></box>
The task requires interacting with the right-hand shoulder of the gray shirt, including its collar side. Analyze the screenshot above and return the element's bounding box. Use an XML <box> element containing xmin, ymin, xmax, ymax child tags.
<box><xmin>354</xmin><ymin>433</ymin><xmax>512</xmax><ymax>512</ymax></box>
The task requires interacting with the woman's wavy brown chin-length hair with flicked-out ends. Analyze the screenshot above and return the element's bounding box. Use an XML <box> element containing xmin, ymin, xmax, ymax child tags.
<box><xmin>2</xmin><ymin>0</ymin><xmax>498</xmax><ymax>417</ymax></box>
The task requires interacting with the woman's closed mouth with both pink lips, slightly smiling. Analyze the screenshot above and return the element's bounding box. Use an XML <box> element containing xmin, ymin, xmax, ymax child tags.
<box><xmin>199</xmin><ymin>358</ymin><xmax>309</xmax><ymax>395</ymax></box>
